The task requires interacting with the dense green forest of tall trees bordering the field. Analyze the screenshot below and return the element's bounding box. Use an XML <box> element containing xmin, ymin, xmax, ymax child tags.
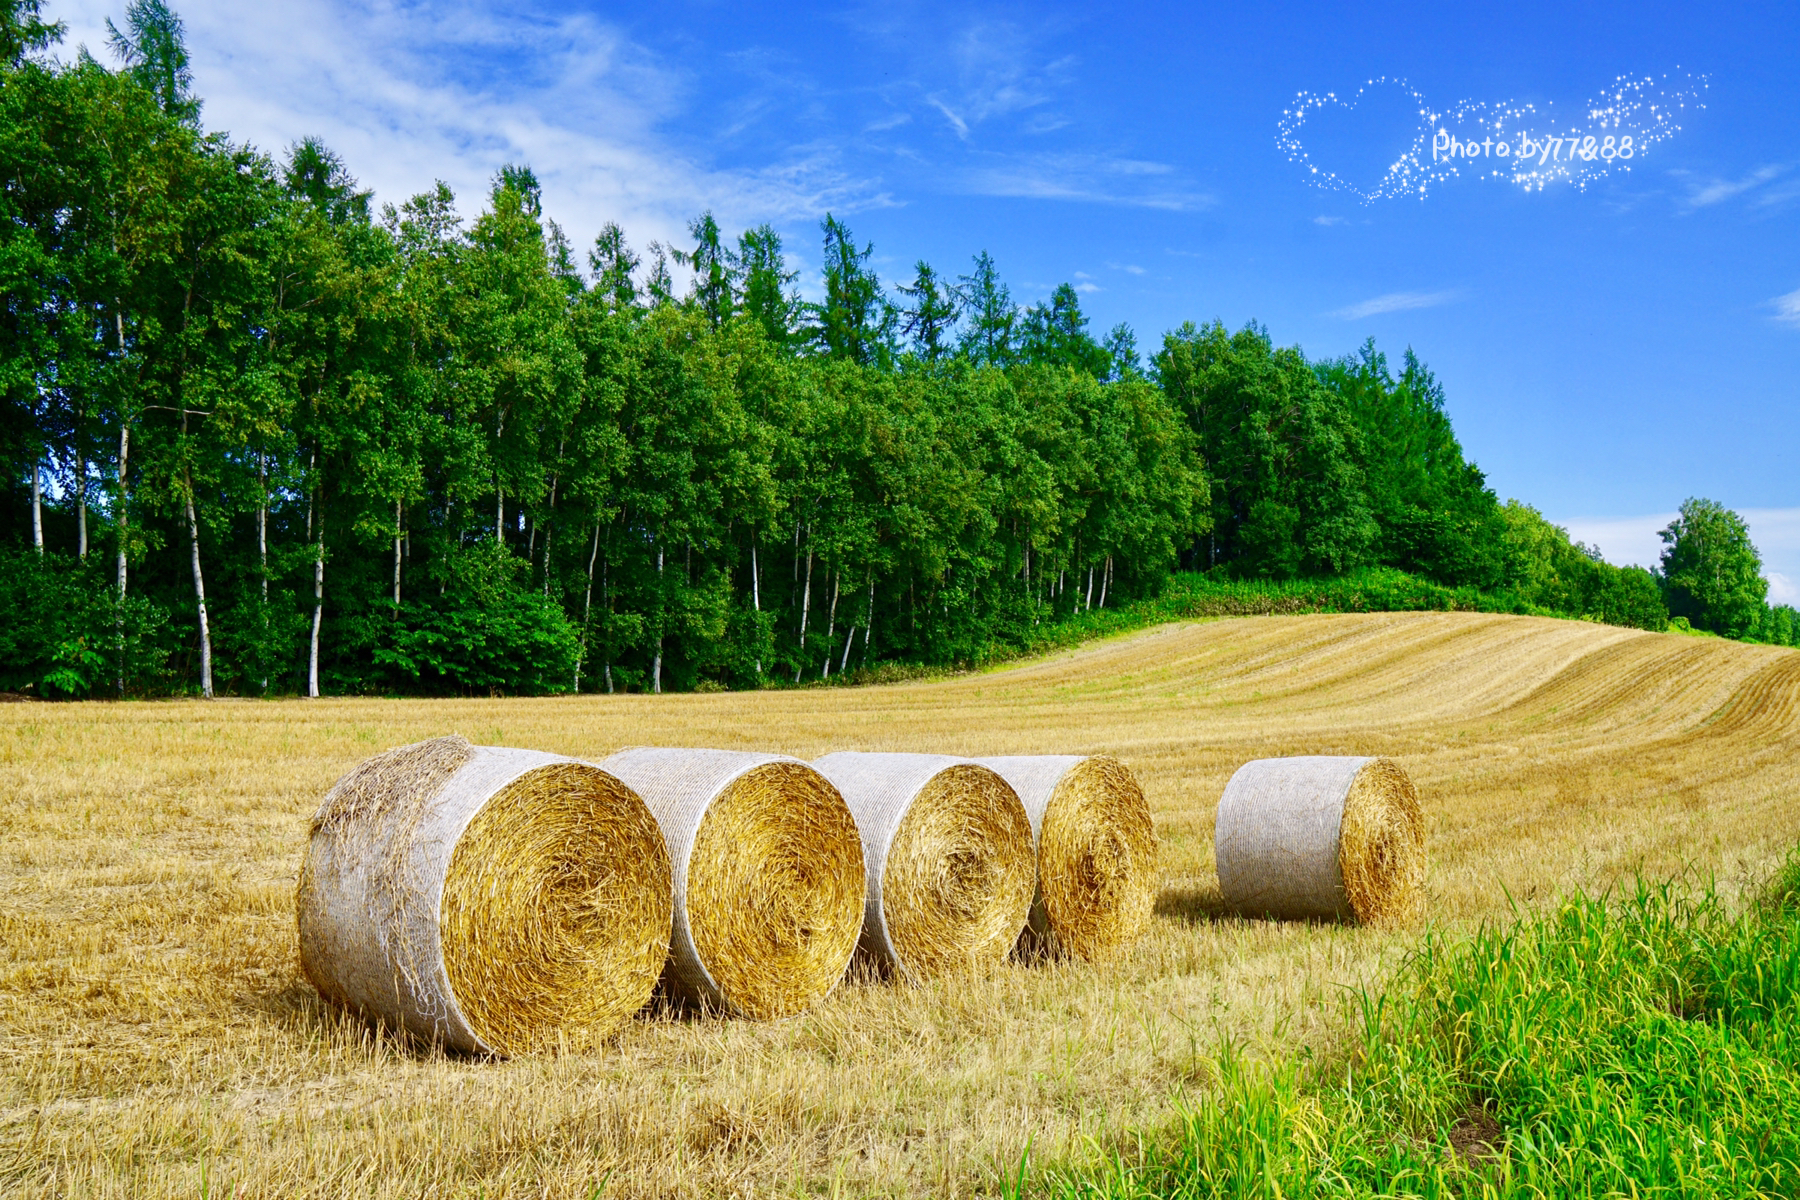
<box><xmin>0</xmin><ymin>0</ymin><xmax>1796</xmax><ymax>696</ymax></box>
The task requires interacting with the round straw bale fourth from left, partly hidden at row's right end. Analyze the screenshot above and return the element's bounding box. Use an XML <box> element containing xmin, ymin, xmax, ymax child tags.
<box><xmin>976</xmin><ymin>754</ymin><xmax>1156</xmax><ymax>963</ymax></box>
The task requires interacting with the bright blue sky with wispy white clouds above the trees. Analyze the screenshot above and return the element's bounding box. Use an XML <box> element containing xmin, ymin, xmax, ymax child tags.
<box><xmin>45</xmin><ymin>0</ymin><xmax>1800</xmax><ymax>603</ymax></box>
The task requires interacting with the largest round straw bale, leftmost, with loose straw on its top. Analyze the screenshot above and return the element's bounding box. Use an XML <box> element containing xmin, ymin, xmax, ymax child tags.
<box><xmin>295</xmin><ymin>738</ymin><xmax>670</xmax><ymax>1054</ymax></box>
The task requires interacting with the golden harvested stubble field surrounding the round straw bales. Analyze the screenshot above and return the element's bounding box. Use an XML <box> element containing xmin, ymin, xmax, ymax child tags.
<box><xmin>10</xmin><ymin>613</ymin><xmax>1800</xmax><ymax>1196</ymax></box>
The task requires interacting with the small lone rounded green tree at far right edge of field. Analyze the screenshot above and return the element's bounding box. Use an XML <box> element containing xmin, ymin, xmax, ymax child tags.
<box><xmin>1661</xmin><ymin>498</ymin><xmax>1769</xmax><ymax>637</ymax></box>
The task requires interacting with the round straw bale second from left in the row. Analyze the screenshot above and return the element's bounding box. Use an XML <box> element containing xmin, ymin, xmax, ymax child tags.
<box><xmin>601</xmin><ymin>747</ymin><xmax>862</xmax><ymax>1020</ymax></box>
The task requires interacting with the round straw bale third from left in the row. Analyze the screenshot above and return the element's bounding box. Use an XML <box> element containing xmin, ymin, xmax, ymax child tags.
<box><xmin>814</xmin><ymin>752</ymin><xmax>1037</xmax><ymax>982</ymax></box>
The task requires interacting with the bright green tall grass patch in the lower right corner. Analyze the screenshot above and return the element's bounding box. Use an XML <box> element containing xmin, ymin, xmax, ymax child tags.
<box><xmin>1046</xmin><ymin>856</ymin><xmax>1800</xmax><ymax>1200</ymax></box>
